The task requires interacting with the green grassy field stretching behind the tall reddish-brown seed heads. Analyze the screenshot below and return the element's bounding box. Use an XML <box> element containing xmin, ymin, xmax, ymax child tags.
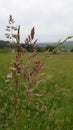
<box><xmin>0</xmin><ymin>52</ymin><xmax>73</xmax><ymax>130</ymax></box>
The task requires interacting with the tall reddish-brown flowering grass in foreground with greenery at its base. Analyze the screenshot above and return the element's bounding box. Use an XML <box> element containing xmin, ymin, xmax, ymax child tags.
<box><xmin>0</xmin><ymin>15</ymin><xmax>46</xmax><ymax>130</ymax></box>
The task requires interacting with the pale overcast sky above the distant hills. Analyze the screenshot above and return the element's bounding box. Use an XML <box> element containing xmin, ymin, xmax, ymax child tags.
<box><xmin>0</xmin><ymin>0</ymin><xmax>73</xmax><ymax>42</ymax></box>
